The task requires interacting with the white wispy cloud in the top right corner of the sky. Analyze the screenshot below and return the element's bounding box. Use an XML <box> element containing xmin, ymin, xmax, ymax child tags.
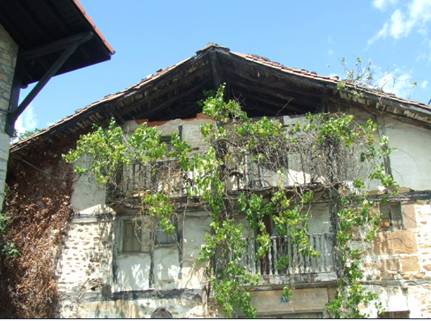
<box><xmin>368</xmin><ymin>0</ymin><xmax>431</xmax><ymax>44</ymax></box>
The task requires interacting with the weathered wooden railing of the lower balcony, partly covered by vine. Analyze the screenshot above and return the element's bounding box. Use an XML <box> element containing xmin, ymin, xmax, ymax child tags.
<box><xmin>244</xmin><ymin>233</ymin><xmax>335</xmax><ymax>276</ymax></box>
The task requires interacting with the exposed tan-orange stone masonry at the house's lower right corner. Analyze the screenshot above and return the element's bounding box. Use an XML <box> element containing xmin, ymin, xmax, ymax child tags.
<box><xmin>364</xmin><ymin>200</ymin><xmax>431</xmax><ymax>318</ymax></box>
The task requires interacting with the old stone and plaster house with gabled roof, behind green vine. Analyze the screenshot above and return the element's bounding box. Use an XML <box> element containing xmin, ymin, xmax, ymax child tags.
<box><xmin>7</xmin><ymin>45</ymin><xmax>431</xmax><ymax>317</ymax></box>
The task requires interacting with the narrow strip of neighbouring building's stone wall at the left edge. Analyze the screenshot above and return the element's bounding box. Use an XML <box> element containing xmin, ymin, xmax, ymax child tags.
<box><xmin>0</xmin><ymin>25</ymin><xmax>18</xmax><ymax>210</ymax></box>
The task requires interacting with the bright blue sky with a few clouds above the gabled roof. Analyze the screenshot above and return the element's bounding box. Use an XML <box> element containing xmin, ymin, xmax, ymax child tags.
<box><xmin>16</xmin><ymin>0</ymin><xmax>431</xmax><ymax>132</ymax></box>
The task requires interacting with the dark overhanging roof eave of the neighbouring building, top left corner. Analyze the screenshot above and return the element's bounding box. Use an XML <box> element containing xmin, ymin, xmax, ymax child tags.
<box><xmin>0</xmin><ymin>0</ymin><xmax>114</xmax><ymax>85</ymax></box>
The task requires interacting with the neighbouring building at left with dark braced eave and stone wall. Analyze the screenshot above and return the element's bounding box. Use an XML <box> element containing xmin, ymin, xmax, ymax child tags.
<box><xmin>0</xmin><ymin>0</ymin><xmax>114</xmax><ymax>209</ymax></box>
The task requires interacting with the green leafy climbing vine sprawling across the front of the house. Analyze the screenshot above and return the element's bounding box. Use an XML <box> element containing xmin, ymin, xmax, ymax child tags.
<box><xmin>64</xmin><ymin>86</ymin><xmax>397</xmax><ymax>317</ymax></box>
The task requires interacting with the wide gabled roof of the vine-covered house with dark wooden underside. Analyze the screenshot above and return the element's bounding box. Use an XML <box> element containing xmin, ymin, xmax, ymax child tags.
<box><xmin>11</xmin><ymin>45</ymin><xmax>431</xmax><ymax>155</ymax></box>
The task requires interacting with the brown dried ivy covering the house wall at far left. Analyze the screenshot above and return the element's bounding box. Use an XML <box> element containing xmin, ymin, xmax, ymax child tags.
<box><xmin>0</xmin><ymin>146</ymin><xmax>74</xmax><ymax>318</ymax></box>
